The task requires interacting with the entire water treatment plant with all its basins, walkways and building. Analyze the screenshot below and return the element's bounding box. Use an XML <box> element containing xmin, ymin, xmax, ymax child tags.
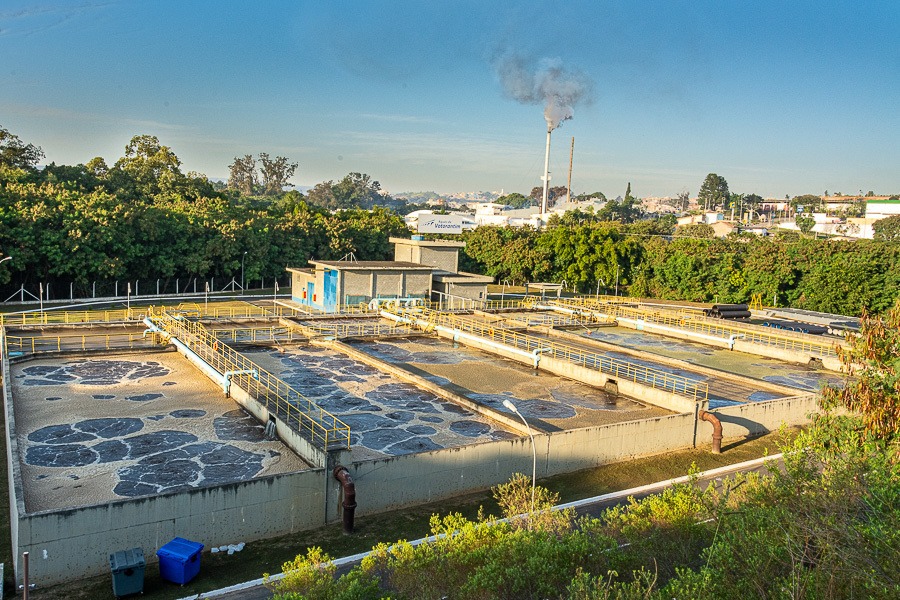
<box><xmin>2</xmin><ymin>243</ymin><xmax>842</xmax><ymax>585</ymax></box>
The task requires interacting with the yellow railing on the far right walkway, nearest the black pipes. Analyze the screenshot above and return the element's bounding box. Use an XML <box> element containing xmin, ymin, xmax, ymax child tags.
<box><xmin>553</xmin><ymin>298</ymin><xmax>839</xmax><ymax>356</ymax></box>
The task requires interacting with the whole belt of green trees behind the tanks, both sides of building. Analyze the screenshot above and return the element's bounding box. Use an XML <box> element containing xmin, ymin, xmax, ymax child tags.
<box><xmin>0</xmin><ymin>127</ymin><xmax>900</xmax><ymax>315</ymax></box>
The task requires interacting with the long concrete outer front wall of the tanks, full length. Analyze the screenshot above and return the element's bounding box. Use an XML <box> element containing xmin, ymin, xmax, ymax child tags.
<box><xmin>7</xmin><ymin>390</ymin><xmax>814</xmax><ymax>586</ymax></box>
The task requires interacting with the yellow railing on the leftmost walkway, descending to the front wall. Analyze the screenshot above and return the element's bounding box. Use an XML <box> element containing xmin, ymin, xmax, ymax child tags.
<box><xmin>150</xmin><ymin>312</ymin><xmax>350</xmax><ymax>450</ymax></box>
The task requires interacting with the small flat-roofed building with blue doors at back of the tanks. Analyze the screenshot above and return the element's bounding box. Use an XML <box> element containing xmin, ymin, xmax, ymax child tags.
<box><xmin>287</xmin><ymin>236</ymin><xmax>494</xmax><ymax>312</ymax></box>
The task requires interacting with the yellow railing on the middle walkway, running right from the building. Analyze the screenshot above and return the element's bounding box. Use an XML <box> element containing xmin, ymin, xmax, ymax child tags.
<box><xmin>395</xmin><ymin>309</ymin><xmax>709</xmax><ymax>401</ymax></box>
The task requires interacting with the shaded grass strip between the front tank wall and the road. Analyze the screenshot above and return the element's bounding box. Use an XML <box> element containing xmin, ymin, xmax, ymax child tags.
<box><xmin>22</xmin><ymin>431</ymin><xmax>796</xmax><ymax>600</ymax></box>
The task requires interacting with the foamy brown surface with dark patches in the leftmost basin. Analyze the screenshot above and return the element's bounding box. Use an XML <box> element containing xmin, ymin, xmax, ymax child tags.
<box><xmin>10</xmin><ymin>352</ymin><xmax>309</xmax><ymax>512</ymax></box>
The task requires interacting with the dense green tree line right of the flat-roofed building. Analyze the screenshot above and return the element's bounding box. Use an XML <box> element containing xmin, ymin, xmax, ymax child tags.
<box><xmin>462</xmin><ymin>217</ymin><xmax>900</xmax><ymax>316</ymax></box>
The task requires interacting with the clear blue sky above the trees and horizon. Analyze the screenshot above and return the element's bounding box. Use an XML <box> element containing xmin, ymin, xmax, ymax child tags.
<box><xmin>0</xmin><ymin>0</ymin><xmax>900</xmax><ymax>197</ymax></box>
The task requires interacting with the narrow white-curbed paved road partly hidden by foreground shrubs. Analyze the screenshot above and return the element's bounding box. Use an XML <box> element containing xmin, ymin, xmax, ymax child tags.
<box><xmin>182</xmin><ymin>454</ymin><xmax>784</xmax><ymax>600</ymax></box>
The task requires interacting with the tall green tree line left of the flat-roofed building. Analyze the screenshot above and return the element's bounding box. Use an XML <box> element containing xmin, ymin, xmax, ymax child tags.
<box><xmin>0</xmin><ymin>128</ymin><xmax>408</xmax><ymax>295</ymax></box>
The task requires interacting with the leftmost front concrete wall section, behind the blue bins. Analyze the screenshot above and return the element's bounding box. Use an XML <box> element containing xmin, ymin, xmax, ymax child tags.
<box><xmin>13</xmin><ymin>469</ymin><xmax>326</xmax><ymax>587</ymax></box>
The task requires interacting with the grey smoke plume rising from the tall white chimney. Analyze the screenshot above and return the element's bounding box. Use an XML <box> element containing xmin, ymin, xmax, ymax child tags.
<box><xmin>494</xmin><ymin>55</ymin><xmax>593</xmax><ymax>131</ymax></box>
